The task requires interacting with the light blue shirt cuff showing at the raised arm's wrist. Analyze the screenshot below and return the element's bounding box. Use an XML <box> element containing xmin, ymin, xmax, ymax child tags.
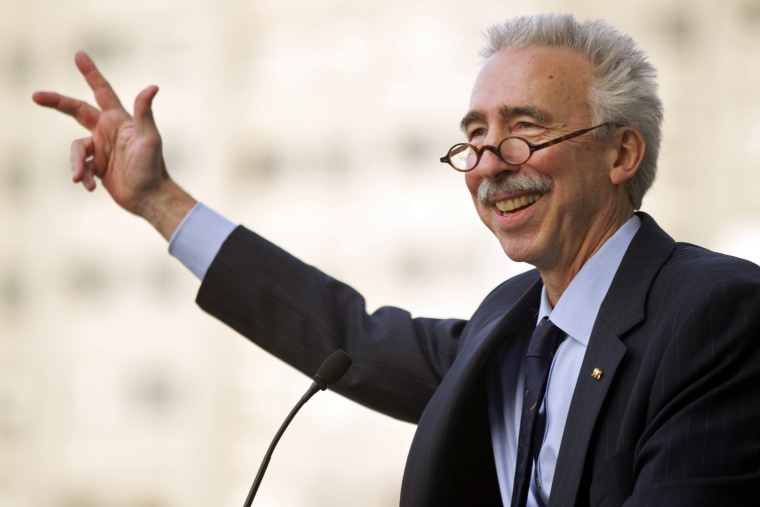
<box><xmin>169</xmin><ymin>203</ymin><xmax>237</xmax><ymax>280</ymax></box>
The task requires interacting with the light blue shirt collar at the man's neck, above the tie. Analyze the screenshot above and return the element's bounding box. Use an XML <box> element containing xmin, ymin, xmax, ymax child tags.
<box><xmin>538</xmin><ymin>215</ymin><xmax>641</xmax><ymax>345</ymax></box>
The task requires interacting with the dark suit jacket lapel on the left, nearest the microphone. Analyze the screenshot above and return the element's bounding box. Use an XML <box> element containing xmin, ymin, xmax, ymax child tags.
<box><xmin>401</xmin><ymin>272</ymin><xmax>541</xmax><ymax>507</ymax></box>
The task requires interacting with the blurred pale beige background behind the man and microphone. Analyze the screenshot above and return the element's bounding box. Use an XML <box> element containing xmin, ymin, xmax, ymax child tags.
<box><xmin>0</xmin><ymin>0</ymin><xmax>760</xmax><ymax>507</ymax></box>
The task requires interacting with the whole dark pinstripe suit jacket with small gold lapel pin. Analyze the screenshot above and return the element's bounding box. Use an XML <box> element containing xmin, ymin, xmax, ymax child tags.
<box><xmin>198</xmin><ymin>214</ymin><xmax>760</xmax><ymax>507</ymax></box>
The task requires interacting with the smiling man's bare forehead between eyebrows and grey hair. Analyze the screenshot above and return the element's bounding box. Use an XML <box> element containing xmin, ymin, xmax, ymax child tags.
<box><xmin>470</xmin><ymin>47</ymin><xmax>593</xmax><ymax>123</ymax></box>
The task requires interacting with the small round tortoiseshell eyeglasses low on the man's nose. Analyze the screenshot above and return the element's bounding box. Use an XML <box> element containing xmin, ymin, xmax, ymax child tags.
<box><xmin>441</xmin><ymin>123</ymin><xmax>611</xmax><ymax>172</ymax></box>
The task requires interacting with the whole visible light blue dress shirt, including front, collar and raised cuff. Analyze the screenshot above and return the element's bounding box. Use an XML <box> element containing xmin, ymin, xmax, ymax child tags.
<box><xmin>169</xmin><ymin>203</ymin><xmax>641</xmax><ymax>507</ymax></box>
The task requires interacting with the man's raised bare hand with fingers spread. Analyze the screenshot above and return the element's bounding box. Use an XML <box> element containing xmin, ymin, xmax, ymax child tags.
<box><xmin>32</xmin><ymin>52</ymin><xmax>195</xmax><ymax>238</ymax></box>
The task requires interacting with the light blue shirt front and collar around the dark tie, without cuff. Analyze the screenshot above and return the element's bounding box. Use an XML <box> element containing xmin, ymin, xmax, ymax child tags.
<box><xmin>488</xmin><ymin>215</ymin><xmax>641</xmax><ymax>507</ymax></box>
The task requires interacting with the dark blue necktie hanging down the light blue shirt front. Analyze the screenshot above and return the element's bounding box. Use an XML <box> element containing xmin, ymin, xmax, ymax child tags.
<box><xmin>512</xmin><ymin>317</ymin><xmax>564</xmax><ymax>507</ymax></box>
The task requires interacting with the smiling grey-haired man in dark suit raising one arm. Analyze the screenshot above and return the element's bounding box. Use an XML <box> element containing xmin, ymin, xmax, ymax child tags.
<box><xmin>34</xmin><ymin>11</ymin><xmax>760</xmax><ymax>506</ymax></box>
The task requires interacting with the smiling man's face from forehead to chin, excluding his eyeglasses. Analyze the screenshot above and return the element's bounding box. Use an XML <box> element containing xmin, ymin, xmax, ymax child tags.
<box><xmin>462</xmin><ymin>47</ymin><xmax>632</xmax><ymax>277</ymax></box>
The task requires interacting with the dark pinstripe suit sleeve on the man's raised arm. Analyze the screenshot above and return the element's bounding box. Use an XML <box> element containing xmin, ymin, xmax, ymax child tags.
<box><xmin>196</xmin><ymin>227</ymin><xmax>466</xmax><ymax>422</ymax></box>
